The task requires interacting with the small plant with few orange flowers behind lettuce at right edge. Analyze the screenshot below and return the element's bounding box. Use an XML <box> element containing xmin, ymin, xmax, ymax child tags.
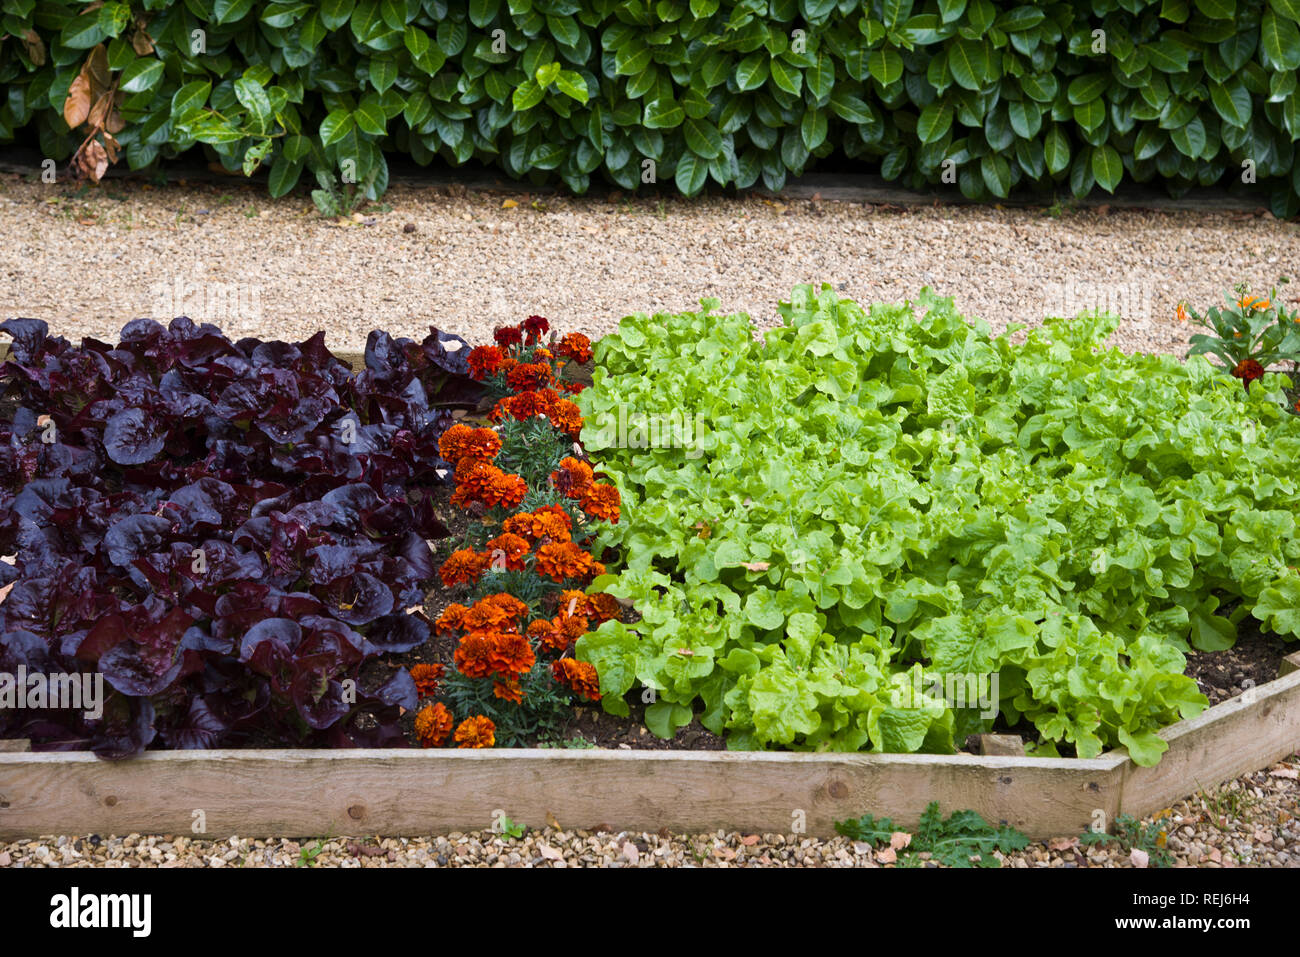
<box><xmin>1178</xmin><ymin>283</ymin><xmax>1300</xmax><ymax>390</ymax></box>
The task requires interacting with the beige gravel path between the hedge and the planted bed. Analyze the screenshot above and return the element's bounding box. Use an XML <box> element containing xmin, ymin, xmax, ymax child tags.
<box><xmin>0</xmin><ymin>174</ymin><xmax>1300</xmax><ymax>354</ymax></box>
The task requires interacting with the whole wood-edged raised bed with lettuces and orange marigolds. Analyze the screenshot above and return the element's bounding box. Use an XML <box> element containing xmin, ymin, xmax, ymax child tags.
<box><xmin>0</xmin><ymin>289</ymin><xmax>1300</xmax><ymax>836</ymax></box>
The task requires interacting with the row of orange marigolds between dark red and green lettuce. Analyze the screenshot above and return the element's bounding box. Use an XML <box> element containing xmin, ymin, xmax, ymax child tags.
<box><xmin>416</xmin><ymin>316</ymin><xmax>620</xmax><ymax>748</ymax></box>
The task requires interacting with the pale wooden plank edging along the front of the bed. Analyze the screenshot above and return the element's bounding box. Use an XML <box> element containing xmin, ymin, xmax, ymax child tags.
<box><xmin>0</xmin><ymin>672</ymin><xmax>1300</xmax><ymax>840</ymax></box>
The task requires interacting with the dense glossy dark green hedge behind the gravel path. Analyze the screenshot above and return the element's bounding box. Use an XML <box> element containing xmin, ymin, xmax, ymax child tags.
<box><xmin>0</xmin><ymin>0</ymin><xmax>1300</xmax><ymax>215</ymax></box>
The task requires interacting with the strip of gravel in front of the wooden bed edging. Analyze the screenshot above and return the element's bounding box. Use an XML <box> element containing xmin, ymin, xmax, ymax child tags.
<box><xmin>0</xmin><ymin>755</ymin><xmax>1300</xmax><ymax>867</ymax></box>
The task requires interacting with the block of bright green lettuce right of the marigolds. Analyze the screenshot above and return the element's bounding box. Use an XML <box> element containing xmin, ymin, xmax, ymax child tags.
<box><xmin>577</xmin><ymin>286</ymin><xmax>1300</xmax><ymax>765</ymax></box>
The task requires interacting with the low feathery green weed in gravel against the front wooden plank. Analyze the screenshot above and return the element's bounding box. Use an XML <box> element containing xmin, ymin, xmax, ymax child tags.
<box><xmin>835</xmin><ymin>801</ymin><xmax>1030</xmax><ymax>867</ymax></box>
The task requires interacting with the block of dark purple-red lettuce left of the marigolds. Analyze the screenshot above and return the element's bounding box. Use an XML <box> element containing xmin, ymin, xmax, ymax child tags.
<box><xmin>0</xmin><ymin>317</ymin><xmax>481</xmax><ymax>758</ymax></box>
